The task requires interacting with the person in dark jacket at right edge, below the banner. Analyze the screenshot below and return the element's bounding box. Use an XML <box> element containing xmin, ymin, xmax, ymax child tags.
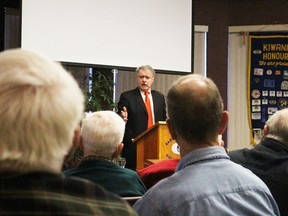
<box><xmin>229</xmin><ymin>108</ymin><xmax>288</xmax><ymax>216</ymax></box>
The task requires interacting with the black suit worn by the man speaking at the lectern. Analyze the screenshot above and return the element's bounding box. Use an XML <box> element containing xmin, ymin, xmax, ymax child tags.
<box><xmin>118</xmin><ymin>87</ymin><xmax>166</xmax><ymax>170</ymax></box>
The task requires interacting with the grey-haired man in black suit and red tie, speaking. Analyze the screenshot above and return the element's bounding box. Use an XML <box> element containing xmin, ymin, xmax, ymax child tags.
<box><xmin>118</xmin><ymin>65</ymin><xmax>166</xmax><ymax>170</ymax></box>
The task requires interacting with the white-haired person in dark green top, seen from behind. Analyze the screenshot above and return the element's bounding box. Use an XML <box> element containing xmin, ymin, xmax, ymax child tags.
<box><xmin>64</xmin><ymin>111</ymin><xmax>146</xmax><ymax>197</ymax></box>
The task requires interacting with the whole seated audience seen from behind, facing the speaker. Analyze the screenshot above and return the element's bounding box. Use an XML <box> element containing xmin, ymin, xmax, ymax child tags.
<box><xmin>0</xmin><ymin>49</ymin><xmax>288</xmax><ymax>216</ymax></box>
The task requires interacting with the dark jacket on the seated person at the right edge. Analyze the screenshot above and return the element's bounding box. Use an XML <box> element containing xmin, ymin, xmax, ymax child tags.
<box><xmin>228</xmin><ymin>138</ymin><xmax>288</xmax><ymax>216</ymax></box>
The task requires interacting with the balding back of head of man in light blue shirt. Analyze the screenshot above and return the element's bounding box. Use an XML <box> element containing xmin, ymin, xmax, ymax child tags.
<box><xmin>167</xmin><ymin>74</ymin><xmax>223</xmax><ymax>144</ymax></box>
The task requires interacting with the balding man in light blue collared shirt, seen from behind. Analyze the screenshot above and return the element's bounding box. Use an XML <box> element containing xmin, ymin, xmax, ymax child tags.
<box><xmin>133</xmin><ymin>74</ymin><xmax>279</xmax><ymax>216</ymax></box>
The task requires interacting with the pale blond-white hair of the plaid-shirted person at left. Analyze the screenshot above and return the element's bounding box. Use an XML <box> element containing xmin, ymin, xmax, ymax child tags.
<box><xmin>0</xmin><ymin>49</ymin><xmax>84</xmax><ymax>170</ymax></box>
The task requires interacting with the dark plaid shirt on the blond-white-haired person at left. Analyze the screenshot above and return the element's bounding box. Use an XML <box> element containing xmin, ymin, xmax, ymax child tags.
<box><xmin>0</xmin><ymin>173</ymin><xmax>137</xmax><ymax>216</ymax></box>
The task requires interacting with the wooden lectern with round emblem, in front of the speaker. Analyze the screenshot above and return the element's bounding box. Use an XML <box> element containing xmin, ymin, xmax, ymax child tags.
<box><xmin>133</xmin><ymin>121</ymin><xmax>180</xmax><ymax>170</ymax></box>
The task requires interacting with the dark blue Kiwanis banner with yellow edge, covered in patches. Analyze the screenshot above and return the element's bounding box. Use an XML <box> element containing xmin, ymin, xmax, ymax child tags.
<box><xmin>248</xmin><ymin>32</ymin><xmax>288</xmax><ymax>145</ymax></box>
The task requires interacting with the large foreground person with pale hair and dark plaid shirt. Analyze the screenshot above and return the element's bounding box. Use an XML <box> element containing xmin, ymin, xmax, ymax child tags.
<box><xmin>0</xmin><ymin>49</ymin><xmax>136</xmax><ymax>215</ymax></box>
